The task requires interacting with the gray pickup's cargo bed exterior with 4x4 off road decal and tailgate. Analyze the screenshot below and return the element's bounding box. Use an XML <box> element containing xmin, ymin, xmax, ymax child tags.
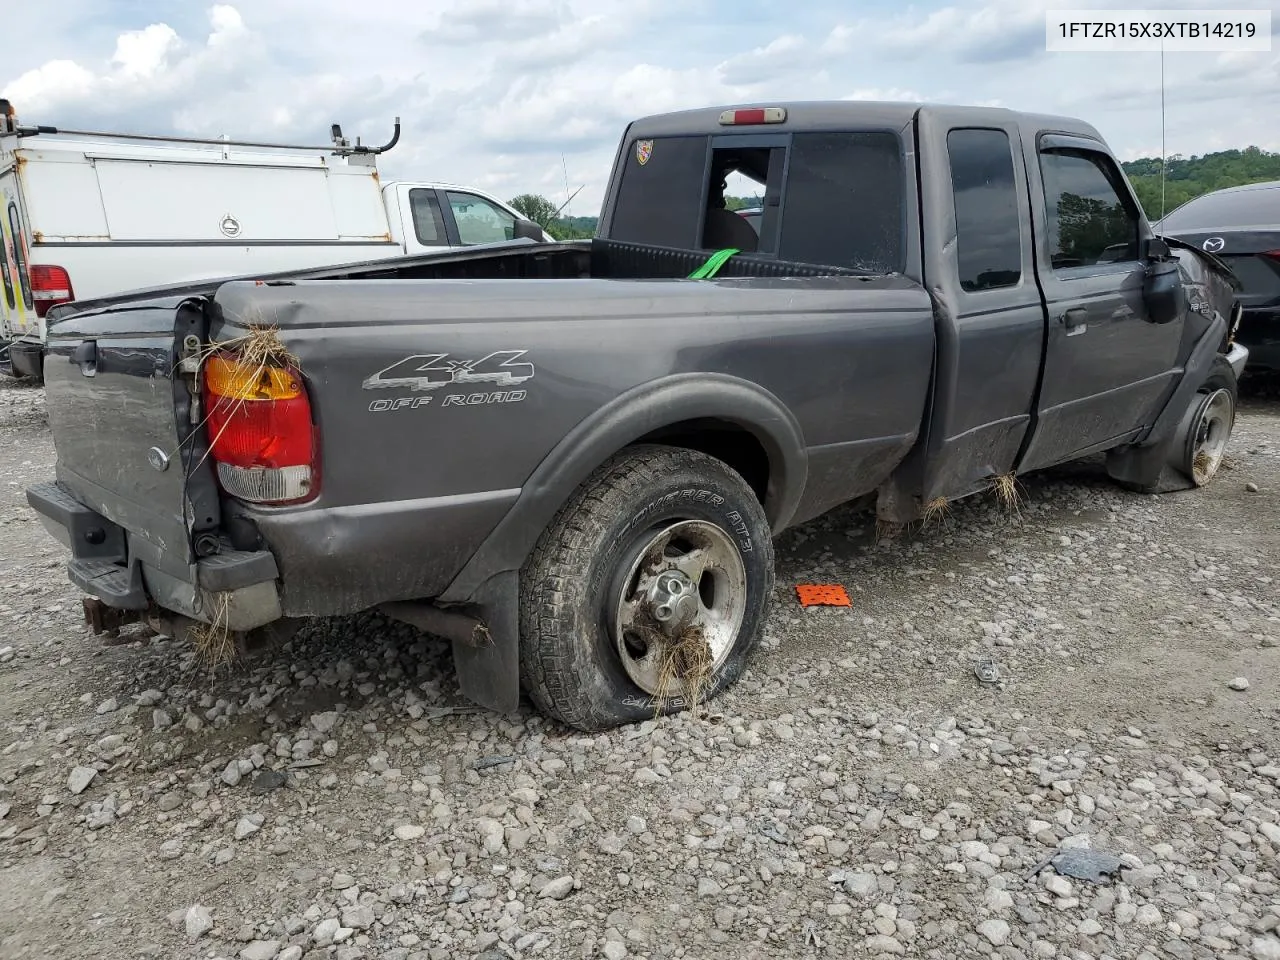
<box><xmin>37</xmin><ymin>241</ymin><xmax>933</xmax><ymax>618</ymax></box>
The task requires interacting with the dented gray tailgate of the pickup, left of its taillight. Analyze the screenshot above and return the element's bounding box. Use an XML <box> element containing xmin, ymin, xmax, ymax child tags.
<box><xmin>45</xmin><ymin>298</ymin><xmax>219</xmax><ymax>560</ymax></box>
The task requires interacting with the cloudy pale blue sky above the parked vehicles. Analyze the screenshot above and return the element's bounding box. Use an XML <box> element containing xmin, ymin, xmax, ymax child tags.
<box><xmin>0</xmin><ymin>0</ymin><xmax>1280</xmax><ymax>215</ymax></box>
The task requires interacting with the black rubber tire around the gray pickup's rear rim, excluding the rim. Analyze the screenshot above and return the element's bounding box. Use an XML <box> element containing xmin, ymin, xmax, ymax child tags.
<box><xmin>520</xmin><ymin>445</ymin><xmax>774</xmax><ymax>732</ymax></box>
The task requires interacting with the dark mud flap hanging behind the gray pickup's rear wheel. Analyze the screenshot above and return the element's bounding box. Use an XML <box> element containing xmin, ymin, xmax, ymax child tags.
<box><xmin>453</xmin><ymin>570</ymin><xmax>520</xmax><ymax>713</ymax></box>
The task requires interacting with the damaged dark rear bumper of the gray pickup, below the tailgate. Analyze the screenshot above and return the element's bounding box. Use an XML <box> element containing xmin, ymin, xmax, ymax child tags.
<box><xmin>27</xmin><ymin>483</ymin><xmax>283</xmax><ymax>631</ymax></box>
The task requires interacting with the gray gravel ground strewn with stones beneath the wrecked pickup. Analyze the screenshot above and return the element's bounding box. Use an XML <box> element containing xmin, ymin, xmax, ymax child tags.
<box><xmin>0</xmin><ymin>381</ymin><xmax>1280</xmax><ymax>960</ymax></box>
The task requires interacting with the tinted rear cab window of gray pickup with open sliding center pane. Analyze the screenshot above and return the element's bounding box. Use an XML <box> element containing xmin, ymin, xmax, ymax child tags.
<box><xmin>608</xmin><ymin>127</ymin><xmax>908</xmax><ymax>274</ymax></box>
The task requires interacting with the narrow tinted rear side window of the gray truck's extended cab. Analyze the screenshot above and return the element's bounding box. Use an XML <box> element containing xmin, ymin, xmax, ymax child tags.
<box><xmin>947</xmin><ymin>129</ymin><xmax>1023</xmax><ymax>292</ymax></box>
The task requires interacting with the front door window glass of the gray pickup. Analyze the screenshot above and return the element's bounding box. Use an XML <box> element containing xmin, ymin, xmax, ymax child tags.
<box><xmin>1041</xmin><ymin>150</ymin><xmax>1138</xmax><ymax>270</ymax></box>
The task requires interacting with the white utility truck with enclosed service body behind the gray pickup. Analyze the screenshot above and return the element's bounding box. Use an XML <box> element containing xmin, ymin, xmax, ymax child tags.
<box><xmin>0</xmin><ymin>100</ymin><xmax>550</xmax><ymax>378</ymax></box>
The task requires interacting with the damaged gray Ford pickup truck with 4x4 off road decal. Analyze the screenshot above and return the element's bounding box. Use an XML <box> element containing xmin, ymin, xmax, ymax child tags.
<box><xmin>28</xmin><ymin>102</ymin><xmax>1247</xmax><ymax>731</ymax></box>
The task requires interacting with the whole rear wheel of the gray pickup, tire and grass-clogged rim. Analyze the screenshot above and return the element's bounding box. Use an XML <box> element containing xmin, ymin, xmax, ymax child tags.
<box><xmin>520</xmin><ymin>447</ymin><xmax>773</xmax><ymax>732</ymax></box>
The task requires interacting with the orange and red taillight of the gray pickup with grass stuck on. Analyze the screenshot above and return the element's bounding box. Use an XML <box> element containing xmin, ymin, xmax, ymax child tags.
<box><xmin>204</xmin><ymin>355</ymin><xmax>320</xmax><ymax>504</ymax></box>
